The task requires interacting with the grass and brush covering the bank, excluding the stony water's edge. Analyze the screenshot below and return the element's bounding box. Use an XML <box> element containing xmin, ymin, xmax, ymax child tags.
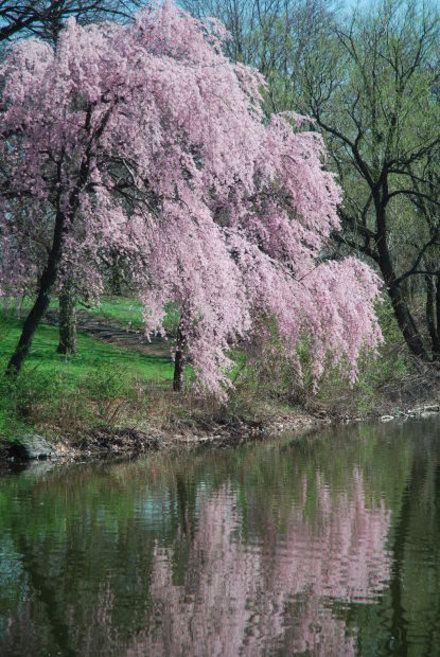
<box><xmin>0</xmin><ymin>297</ymin><xmax>435</xmax><ymax>454</ymax></box>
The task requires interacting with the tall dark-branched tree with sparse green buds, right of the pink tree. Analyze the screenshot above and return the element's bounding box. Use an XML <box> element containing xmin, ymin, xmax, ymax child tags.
<box><xmin>295</xmin><ymin>0</ymin><xmax>440</xmax><ymax>359</ymax></box>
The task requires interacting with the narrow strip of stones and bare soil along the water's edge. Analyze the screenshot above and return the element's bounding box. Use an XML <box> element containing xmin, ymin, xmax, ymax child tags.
<box><xmin>0</xmin><ymin>401</ymin><xmax>440</xmax><ymax>464</ymax></box>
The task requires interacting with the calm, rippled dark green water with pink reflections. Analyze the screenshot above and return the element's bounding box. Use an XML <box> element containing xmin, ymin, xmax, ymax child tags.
<box><xmin>0</xmin><ymin>419</ymin><xmax>440</xmax><ymax>657</ymax></box>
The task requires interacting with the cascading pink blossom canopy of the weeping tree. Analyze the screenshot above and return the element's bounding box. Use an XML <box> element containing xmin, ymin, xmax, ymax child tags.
<box><xmin>0</xmin><ymin>2</ymin><xmax>380</xmax><ymax>396</ymax></box>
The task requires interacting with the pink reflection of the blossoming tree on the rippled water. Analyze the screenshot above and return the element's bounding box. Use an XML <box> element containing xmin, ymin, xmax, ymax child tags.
<box><xmin>137</xmin><ymin>472</ymin><xmax>390</xmax><ymax>657</ymax></box>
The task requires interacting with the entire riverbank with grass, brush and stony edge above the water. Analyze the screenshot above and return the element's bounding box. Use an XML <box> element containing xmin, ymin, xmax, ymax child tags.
<box><xmin>0</xmin><ymin>298</ymin><xmax>440</xmax><ymax>460</ymax></box>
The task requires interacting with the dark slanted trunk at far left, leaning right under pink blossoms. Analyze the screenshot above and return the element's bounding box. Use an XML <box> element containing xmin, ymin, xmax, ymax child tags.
<box><xmin>7</xmin><ymin>211</ymin><xmax>65</xmax><ymax>374</ymax></box>
